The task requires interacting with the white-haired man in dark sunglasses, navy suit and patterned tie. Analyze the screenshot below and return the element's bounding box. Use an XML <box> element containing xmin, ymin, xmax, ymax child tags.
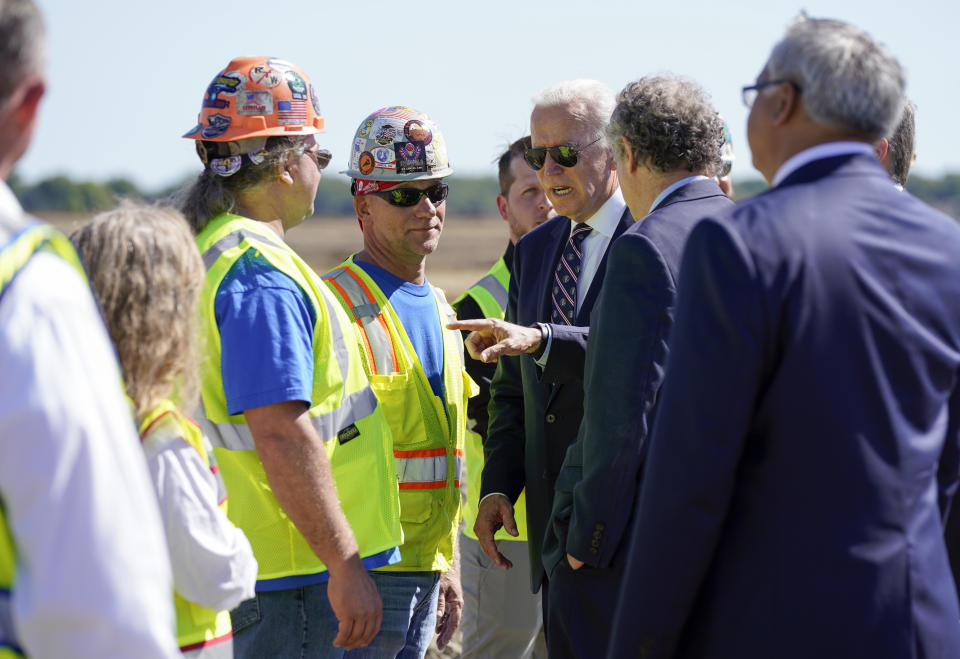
<box><xmin>451</xmin><ymin>80</ymin><xmax>633</xmax><ymax>655</ymax></box>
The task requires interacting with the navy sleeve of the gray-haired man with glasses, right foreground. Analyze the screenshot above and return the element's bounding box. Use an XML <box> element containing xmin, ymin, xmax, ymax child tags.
<box><xmin>609</xmin><ymin>220</ymin><xmax>766</xmax><ymax>657</ymax></box>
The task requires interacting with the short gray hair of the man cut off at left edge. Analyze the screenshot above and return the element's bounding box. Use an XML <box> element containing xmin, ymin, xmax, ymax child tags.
<box><xmin>0</xmin><ymin>0</ymin><xmax>46</xmax><ymax>103</ymax></box>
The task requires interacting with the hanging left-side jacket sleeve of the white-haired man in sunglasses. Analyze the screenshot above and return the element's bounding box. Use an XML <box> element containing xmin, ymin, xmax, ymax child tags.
<box><xmin>480</xmin><ymin>245</ymin><xmax>529</xmax><ymax>503</ymax></box>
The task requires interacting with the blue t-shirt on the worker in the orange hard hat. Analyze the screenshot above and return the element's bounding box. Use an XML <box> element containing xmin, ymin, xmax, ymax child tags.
<box><xmin>213</xmin><ymin>249</ymin><xmax>400</xmax><ymax>592</ymax></box>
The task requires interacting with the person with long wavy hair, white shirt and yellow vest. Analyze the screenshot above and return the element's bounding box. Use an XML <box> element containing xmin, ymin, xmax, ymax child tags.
<box><xmin>71</xmin><ymin>202</ymin><xmax>257</xmax><ymax>659</ymax></box>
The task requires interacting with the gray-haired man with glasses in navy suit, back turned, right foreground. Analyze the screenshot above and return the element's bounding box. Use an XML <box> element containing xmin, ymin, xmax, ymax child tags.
<box><xmin>608</xmin><ymin>16</ymin><xmax>960</xmax><ymax>659</ymax></box>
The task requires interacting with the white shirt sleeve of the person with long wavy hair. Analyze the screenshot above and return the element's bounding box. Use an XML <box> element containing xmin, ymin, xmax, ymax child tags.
<box><xmin>143</xmin><ymin>428</ymin><xmax>257</xmax><ymax>611</ymax></box>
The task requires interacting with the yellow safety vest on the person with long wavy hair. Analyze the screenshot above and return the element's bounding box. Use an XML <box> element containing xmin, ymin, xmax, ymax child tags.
<box><xmin>140</xmin><ymin>400</ymin><xmax>233</xmax><ymax>657</ymax></box>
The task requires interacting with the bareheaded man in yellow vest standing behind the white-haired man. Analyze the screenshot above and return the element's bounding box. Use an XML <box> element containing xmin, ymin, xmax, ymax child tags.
<box><xmin>453</xmin><ymin>136</ymin><xmax>557</xmax><ymax>659</ymax></box>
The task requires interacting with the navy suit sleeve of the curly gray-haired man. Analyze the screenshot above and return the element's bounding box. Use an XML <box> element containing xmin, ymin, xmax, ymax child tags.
<box><xmin>565</xmin><ymin>234</ymin><xmax>676</xmax><ymax>567</ymax></box>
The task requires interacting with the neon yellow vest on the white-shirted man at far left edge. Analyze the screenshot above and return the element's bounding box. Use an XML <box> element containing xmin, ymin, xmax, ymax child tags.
<box><xmin>0</xmin><ymin>224</ymin><xmax>87</xmax><ymax>659</ymax></box>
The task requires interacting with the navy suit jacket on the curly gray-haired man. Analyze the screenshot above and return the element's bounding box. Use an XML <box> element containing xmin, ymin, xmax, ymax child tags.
<box><xmin>543</xmin><ymin>175</ymin><xmax>733</xmax><ymax>572</ymax></box>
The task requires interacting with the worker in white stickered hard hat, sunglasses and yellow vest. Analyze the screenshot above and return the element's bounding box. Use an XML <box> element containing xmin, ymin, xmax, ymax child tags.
<box><xmin>324</xmin><ymin>107</ymin><xmax>476</xmax><ymax>657</ymax></box>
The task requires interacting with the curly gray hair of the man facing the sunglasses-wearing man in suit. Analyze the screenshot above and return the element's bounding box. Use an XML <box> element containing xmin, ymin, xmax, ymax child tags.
<box><xmin>607</xmin><ymin>76</ymin><xmax>724</xmax><ymax>176</ymax></box>
